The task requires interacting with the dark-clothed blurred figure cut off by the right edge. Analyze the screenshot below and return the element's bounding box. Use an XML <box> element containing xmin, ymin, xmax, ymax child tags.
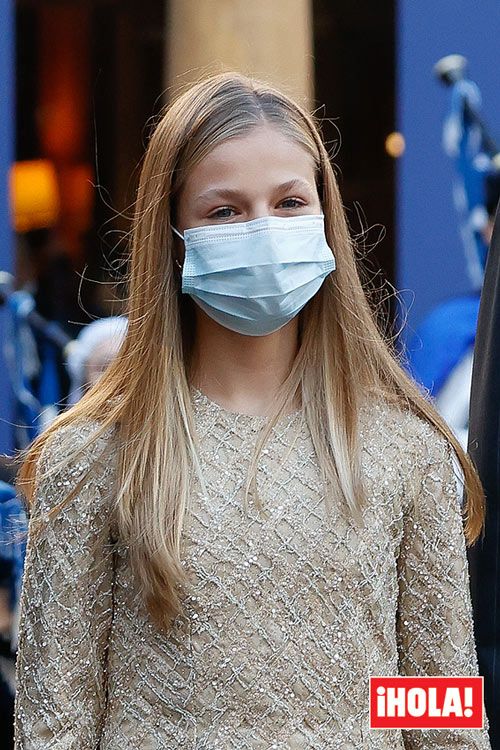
<box><xmin>468</xmin><ymin>197</ymin><xmax>500</xmax><ymax>750</ymax></box>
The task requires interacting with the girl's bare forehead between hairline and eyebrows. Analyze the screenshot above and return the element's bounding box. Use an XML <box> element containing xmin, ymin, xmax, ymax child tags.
<box><xmin>180</xmin><ymin>125</ymin><xmax>315</xmax><ymax>193</ymax></box>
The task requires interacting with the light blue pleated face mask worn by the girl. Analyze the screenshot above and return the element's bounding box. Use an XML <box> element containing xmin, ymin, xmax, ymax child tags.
<box><xmin>173</xmin><ymin>214</ymin><xmax>335</xmax><ymax>336</ymax></box>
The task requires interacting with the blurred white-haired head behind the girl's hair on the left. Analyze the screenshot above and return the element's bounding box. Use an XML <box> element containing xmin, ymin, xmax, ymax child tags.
<box><xmin>66</xmin><ymin>315</ymin><xmax>127</xmax><ymax>406</ymax></box>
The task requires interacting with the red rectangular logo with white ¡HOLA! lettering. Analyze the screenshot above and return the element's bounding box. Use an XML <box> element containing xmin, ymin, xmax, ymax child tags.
<box><xmin>370</xmin><ymin>676</ymin><xmax>484</xmax><ymax>729</ymax></box>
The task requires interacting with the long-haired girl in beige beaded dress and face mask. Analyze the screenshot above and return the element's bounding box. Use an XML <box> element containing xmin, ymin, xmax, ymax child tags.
<box><xmin>15</xmin><ymin>73</ymin><xmax>490</xmax><ymax>750</ymax></box>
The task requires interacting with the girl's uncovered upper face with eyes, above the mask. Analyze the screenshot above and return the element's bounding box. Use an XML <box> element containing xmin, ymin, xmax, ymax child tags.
<box><xmin>174</xmin><ymin>125</ymin><xmax>322</xmax><ymax>262</ymax></box>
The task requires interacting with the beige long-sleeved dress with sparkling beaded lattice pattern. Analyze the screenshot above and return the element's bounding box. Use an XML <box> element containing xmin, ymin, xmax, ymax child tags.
<box><xmin>15</xmin><ymin>388</ymin><xmax>491</xmax><ymax>750</ymax></box>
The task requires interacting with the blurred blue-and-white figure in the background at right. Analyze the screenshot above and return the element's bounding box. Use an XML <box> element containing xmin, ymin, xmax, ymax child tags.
<box><xmin>406</xmin><ymin>54</ymin><xmax>500</xmax><ymax>450</ymax></box>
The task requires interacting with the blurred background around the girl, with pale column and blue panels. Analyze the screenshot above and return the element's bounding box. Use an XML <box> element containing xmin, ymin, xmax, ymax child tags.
<box><xmin>0</xmin><ymin>0</ymin><xmax>500</xmax><ymax>747</ymax></box>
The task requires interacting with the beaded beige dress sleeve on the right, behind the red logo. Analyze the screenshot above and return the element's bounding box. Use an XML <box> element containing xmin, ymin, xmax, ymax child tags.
<box><xmin>396</xmin><ymin>428</ymin><xmax>491</xmax><ymax>750</ymax></box>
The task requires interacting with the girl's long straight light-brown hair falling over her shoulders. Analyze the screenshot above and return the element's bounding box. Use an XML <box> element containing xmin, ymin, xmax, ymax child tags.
<box><xmin>14</xmin><ymin>72</ymin><xmax>484</xmax><ymax>627</ymax></box>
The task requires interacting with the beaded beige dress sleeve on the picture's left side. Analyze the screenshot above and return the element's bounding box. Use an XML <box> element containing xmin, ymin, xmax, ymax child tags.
<box><xmin>14</xmin><ymin>420</ymin><xmax>113</xmax><ymax>750</ymax></box>
